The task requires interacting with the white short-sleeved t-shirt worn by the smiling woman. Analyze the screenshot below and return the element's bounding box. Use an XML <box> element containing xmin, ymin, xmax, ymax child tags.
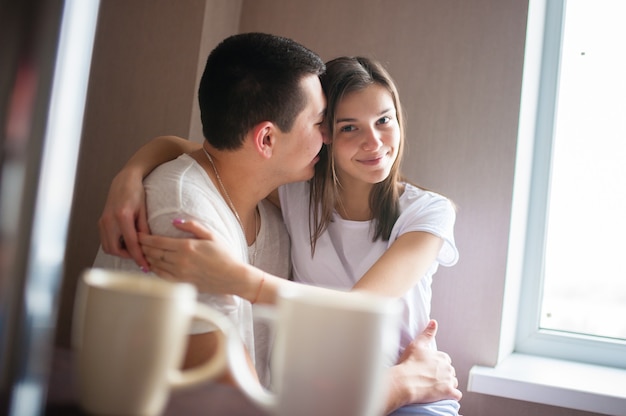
<box><xmin>279</xmin><ymin>182</ymin><xmax>458</xmax><ymax>365</ymax></box>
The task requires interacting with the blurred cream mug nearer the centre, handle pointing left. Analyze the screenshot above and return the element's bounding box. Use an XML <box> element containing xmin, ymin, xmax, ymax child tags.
<box><xmin>229</xmin><ymin>287</ymin><xmax>400</xmax><ymax>416</ymax></box>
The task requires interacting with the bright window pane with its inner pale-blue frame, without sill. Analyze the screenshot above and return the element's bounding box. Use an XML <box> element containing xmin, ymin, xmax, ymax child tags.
<box><xmin>515</xmin><ymin>0</ymin><xmax>626</xmax><ymax>368</ymax></box>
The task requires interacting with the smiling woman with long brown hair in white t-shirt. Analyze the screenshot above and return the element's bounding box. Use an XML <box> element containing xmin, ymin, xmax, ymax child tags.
<box><xmin>98</xmin><ymin>57</ymin><xmax>459</xmax><ymax>415</ymax></box>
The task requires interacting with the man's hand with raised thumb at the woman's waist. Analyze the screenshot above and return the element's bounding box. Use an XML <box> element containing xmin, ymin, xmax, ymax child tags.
<box><xmin>386</xmin><ymin>320</ymin><xmax>462</xmax><ymax>413</ymax></box>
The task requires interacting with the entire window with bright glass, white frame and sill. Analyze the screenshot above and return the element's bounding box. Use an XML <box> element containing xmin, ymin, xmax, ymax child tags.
<box><xmin>468</xmin><ymin>0</ymin><xmax>626</xmax><ymax>415</ymax></box>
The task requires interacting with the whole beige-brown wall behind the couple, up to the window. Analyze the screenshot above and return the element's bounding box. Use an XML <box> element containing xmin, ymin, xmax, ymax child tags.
<box><xmin>59</xmin><ymin>0</ymin><xmax>588</xmax><ymax>416</ymax></box>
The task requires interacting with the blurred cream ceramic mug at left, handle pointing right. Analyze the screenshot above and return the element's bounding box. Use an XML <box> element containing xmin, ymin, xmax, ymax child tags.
<box><xmin>72</xmin><ymin>269</ymin><xmax>237</xmax><ymax>415</ymax></box>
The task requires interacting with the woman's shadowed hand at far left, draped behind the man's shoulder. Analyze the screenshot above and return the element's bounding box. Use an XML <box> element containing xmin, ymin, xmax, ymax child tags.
<box><xmin>98</xmin><ymin>170</ymin><xmax>150</xmax><ymax>270</ymax></box>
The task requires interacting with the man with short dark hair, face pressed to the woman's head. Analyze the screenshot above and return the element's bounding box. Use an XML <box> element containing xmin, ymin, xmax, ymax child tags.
<box><xmin>96</xmin><ymin>33</ymin><xmax>460</xmax><ymax>409</ymax></box>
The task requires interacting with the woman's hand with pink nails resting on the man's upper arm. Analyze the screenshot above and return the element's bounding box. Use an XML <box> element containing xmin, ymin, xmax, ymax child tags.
<box><xmin>139</xmin><ymin>219</ymin><xmax>243</xmax><ymax>294</ymax></box>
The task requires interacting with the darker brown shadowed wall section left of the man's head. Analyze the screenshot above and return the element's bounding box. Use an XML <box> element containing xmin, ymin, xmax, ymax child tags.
<box><xmin>57</xmin><ymin>0</ymin><xmax>241</xmax><ymax>345</ymax></box>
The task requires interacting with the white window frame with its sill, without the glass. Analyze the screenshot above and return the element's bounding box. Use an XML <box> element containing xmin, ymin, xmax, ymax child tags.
<box><xmin>468</xmin><ymin>0</ymin><xmax>626</xmax><ymax>415</ymax></box>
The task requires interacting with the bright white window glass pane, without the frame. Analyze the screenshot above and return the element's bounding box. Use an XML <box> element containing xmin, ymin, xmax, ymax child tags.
<box><xmin>539</xmin><ymin>0</ymin><xmax>626</xmax><ymax>339</ymax></box>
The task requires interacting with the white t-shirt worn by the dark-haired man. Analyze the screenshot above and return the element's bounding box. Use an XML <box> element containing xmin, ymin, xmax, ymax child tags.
<box><xmin>94</xmin><ymin>154</ymin><xmax>255</xmax><ymax>360</ymax></box>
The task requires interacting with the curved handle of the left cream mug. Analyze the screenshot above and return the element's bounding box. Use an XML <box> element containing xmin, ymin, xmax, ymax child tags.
<box><xmin>170</xmin><ymin>303</ymin><xmax>232</xmax><ymax>389</ymax></box>
